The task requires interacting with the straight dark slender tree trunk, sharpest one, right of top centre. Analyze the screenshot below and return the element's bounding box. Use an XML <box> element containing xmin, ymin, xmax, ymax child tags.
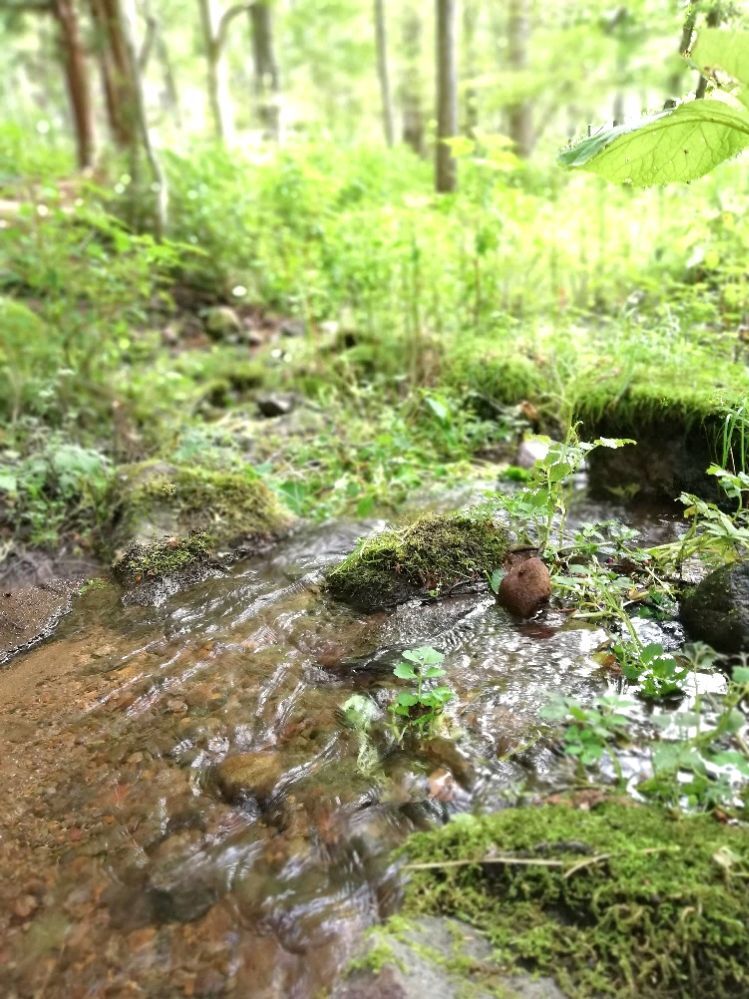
<box><xmin>435</xmin><ymin>0</ymin><xmax>458</xmax><ymax>192</ymax></box>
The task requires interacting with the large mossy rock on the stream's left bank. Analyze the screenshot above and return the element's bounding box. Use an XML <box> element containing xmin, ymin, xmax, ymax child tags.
<box><xmin>112</xmin><ymin>461</ymin><xmax>292</xmax><ymax>587</ymax></box>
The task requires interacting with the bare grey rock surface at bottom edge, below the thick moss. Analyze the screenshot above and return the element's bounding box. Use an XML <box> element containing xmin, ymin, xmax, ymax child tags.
<box><xmin>331</xmin><ymin>916</ymin><xmax>564</xmax><ymax>999</ymax></box>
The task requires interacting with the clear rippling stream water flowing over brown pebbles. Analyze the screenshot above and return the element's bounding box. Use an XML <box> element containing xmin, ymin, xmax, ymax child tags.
<box><xmin>0</xmin><ymin>496</ymin><xmax>688</xmax><ymax>999</ymax></box>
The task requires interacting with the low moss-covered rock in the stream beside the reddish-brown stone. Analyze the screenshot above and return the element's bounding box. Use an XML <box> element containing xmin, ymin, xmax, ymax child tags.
<box><xmin>326</xmin><ymin>513</ymin><xmax>508</xmax><ymax>613</ymax></box>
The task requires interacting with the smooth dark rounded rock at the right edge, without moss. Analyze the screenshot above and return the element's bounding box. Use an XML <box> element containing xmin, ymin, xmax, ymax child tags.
<box><xmin>681</xmin><ymin>562</ymin><xmax>749</xmax><ymax>653</ymax></box>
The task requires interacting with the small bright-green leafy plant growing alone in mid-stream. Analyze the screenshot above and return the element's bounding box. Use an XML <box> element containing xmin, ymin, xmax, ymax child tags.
<box><xmin>389</xmin><ymin>645</ymin><xmax>455</xmax><ymax>742</ymax></box>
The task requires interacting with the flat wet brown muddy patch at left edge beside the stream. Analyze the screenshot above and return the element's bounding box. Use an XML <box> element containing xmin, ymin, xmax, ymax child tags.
<box><xmin>0</xmin><ymin>582</ymin><xmax>74</xmax><ymax>663</ymax></box>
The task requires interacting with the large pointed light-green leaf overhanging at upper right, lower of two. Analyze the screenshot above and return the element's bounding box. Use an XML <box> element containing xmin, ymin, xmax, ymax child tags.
<box><xmin>560</xmin><ymin>100</ymin><xmax>749</xmax><ymax>187</ymax></box>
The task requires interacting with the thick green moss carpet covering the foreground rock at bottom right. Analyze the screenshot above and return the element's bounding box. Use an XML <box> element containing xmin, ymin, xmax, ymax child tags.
<box><xmin>398</xmin><ymin>802</ymin><xmax>749</xmax><ymax>997</ymax></box>
